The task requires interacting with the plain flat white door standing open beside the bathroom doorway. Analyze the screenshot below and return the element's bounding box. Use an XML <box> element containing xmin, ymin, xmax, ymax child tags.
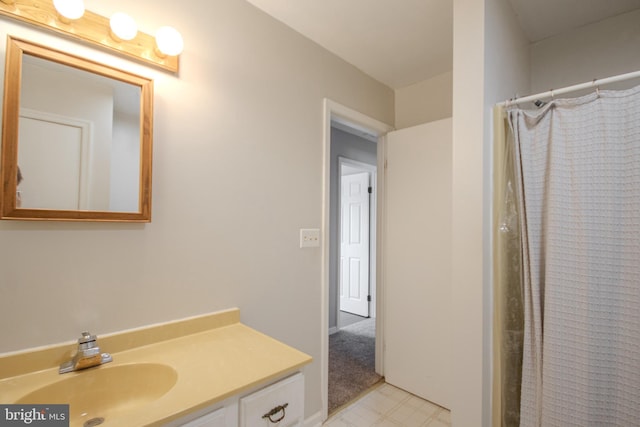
<box><xmin>384</xmin><ymin>119</ymin><xmax>452</xmax><ymax>408</ymax></box>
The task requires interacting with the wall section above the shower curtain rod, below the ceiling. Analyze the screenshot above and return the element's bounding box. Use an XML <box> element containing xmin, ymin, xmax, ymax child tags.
<box><xmin>531</xmin><ymin>10</ymin><xmax>640</xmax><ymax>93</ymax></box>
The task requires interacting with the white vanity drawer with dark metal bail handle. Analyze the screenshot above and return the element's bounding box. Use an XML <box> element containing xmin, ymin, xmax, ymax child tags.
<box><xmin>240</xmin><ymin>373</ymin><xmax>304</xmax><ymax>427</ymax></box>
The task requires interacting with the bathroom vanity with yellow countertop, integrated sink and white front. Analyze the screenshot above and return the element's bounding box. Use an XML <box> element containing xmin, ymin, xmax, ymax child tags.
<box><xmin>0</xmin><ymin>309</ymin><xmax>312</xmax><ymax>427</ymax></box>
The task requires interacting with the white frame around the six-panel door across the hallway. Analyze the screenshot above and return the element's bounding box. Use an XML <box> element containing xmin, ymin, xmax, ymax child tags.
<box><xmin>336</xmin><ymin>156</ymin><xmax>378</xmax><ymax>322</ymax></box>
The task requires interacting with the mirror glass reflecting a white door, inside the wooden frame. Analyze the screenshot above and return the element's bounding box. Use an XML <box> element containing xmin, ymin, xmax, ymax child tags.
<box><xmin>18</xmin><ymin>55</ymin><xmax>140</xmax><ymax>212</ymax></box>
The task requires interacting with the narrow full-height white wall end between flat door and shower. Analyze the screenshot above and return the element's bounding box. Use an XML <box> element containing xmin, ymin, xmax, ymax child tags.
<box><xmin>451</xmin><ymin>0</ymin><xmax>484</xmax><ymax>427</ymax></box>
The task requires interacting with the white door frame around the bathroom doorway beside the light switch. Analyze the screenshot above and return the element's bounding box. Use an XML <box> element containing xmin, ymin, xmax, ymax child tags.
<box><xmin>320</xmin><ymin>98</ymin><xmax>393</xmax><ymax>421</ymax></box>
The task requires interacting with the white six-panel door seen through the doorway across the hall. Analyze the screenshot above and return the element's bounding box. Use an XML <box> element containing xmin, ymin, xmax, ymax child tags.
<box><xmin>339</xmin><ymin>172</ymin><xmax>370</xmax><ymax>317</ymax></box>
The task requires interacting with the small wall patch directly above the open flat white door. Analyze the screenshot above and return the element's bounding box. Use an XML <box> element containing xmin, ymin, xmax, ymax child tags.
<box><xmin>395</xmin><ymin>71</ymin><xmax>453</xmax><ymax>129</ymax></box>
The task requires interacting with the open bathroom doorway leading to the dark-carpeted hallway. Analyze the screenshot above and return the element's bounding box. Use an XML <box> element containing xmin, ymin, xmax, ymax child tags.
<box><xmin>325</xmin><ymin>101</ymin><xmax>389</xmax><ymax>415</ymax></box>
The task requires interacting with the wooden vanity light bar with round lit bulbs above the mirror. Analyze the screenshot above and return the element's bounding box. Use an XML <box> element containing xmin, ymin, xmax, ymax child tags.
<box><xmin>0</xmin><ymin>0</ymin><xmax>184</xmax><ymax>73</ymax></box>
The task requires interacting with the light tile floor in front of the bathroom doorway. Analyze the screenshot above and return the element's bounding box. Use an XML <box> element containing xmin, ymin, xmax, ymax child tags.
<box><xmin>323</xmin><ymin>383</ymin><xmax>451</xmax><ymax>427</ymax></box>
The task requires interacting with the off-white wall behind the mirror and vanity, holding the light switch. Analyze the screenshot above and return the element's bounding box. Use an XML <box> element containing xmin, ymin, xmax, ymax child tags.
<box><xmin>0</xmin><ymin>0</ymin><xmax>394</xmax><ymax>422</ymax></box>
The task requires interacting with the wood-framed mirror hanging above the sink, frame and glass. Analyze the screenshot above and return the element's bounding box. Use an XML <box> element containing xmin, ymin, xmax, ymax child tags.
<box><xmin>0</xmin><ymin>36</ymin><xmax>153</xmax><ymax>222</ymax></box>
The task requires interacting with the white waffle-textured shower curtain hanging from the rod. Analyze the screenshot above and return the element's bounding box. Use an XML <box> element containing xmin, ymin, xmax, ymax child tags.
<box><xmin>508</xmin><ymin>87</ymin><xmax>640</xmax><ymax>427</ymax></box>
